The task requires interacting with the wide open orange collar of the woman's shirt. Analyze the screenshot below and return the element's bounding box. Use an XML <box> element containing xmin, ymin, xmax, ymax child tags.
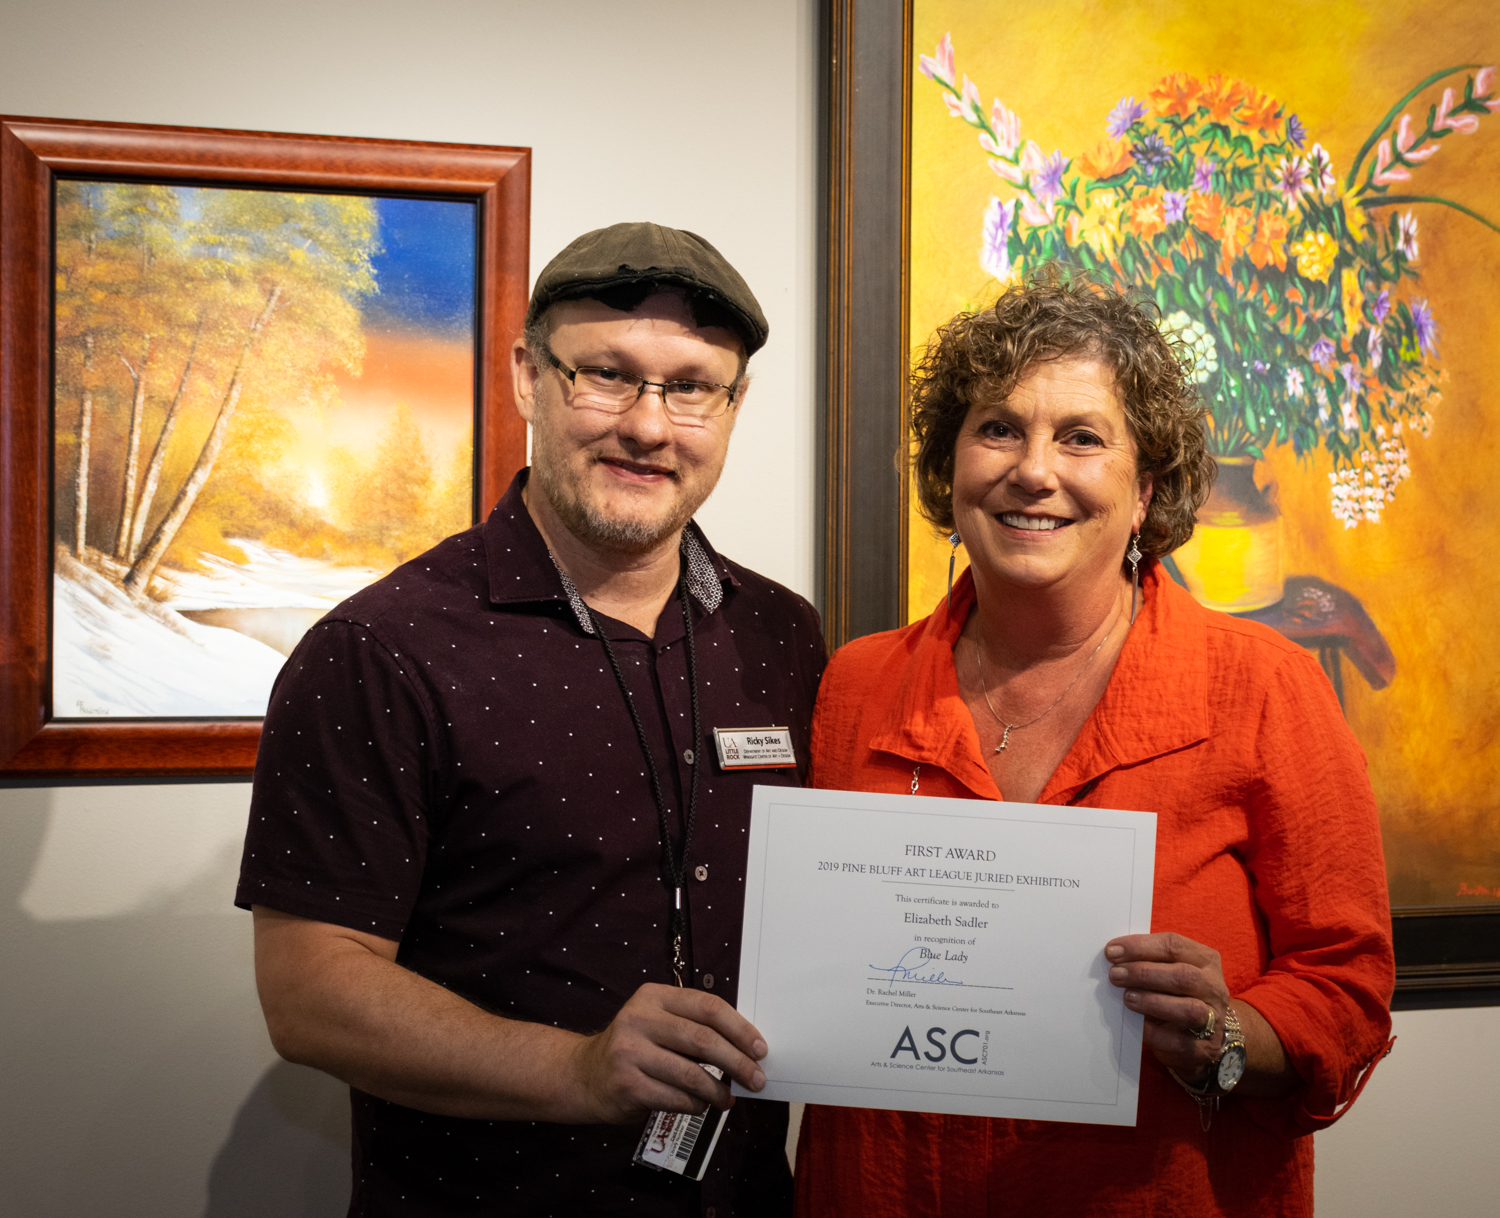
<box><xmin>870</xmin><ymin>563</ymin><xmax>1208</xmax><ymax>803</ymax></box>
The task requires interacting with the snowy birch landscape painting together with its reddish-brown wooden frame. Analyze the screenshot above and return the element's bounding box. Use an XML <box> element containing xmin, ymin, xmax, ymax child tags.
<box><xmin>0</xmin><ymin>120</ymin><xmax>528</xmax><ymax>774</ymax></box>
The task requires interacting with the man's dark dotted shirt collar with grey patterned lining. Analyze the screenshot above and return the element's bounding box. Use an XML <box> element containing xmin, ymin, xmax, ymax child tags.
<box><xmin>483</xmin><ymin>470</ymin><xmax>735</xmax><ymax>635</ymax></box>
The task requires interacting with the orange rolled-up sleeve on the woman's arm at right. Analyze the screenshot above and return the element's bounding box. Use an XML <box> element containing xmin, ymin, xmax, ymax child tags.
<box><xmin>1238</xmin><ymin>653</ymin><xmax>1395</xmax><ymax>1137</ymax></box>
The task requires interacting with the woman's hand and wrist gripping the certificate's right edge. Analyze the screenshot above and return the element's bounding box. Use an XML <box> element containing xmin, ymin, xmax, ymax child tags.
<box><xmin>1104</xmin><ymin>932</ymin><xmax>1302</xmax><ymax>1097</ymax></box>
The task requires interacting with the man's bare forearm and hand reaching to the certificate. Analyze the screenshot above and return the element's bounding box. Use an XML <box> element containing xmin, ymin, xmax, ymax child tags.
<box><xmin>255</xmin><ymin>906</ymin><xmax>765</xmax><ymax>1125</ymax></box>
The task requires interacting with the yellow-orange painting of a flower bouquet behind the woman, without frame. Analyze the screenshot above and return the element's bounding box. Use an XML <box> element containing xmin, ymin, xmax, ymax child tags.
<box><xmin>909</xmin><ymin>2</ymin><xmax>1500</xmax><ymax>906</ymax></box>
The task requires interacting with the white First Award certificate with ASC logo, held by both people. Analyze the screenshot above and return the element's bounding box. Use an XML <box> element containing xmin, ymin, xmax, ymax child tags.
<box><xmin>734</xmin><ymin>786</ymin><xmax>1157</xmax><ymax>1125</ymax></box>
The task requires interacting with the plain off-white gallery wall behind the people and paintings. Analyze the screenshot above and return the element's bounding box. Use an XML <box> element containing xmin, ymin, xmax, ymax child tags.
<box><xmin>0</xmin><ymin>0</ymin><xmax>1500</xmax><ymax>1218</ymax></box>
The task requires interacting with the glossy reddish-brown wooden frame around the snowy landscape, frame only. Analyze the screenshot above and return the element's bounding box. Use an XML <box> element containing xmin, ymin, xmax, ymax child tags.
<box><xmin>0</xmin><ymin>117</ymin><xmax>531</xmax><ymax>779</ymax></box>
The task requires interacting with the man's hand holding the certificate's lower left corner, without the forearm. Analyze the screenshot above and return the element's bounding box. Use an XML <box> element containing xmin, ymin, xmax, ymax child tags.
<box><xmin>573</xmin><ymin>986</ymin><xmax>767</xmax><ymax>1125</ymax></box>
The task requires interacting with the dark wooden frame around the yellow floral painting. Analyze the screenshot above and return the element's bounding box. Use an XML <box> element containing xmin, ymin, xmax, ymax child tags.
<box><xmin>821</xmin><ymin>0</ymin><xmax>1500</xmax><ymax>1008</ymax></box>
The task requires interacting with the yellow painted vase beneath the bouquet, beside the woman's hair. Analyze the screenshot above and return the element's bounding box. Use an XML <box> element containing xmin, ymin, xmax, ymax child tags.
<box><xmin>1172</xmin><ymin>456</ymin><xmax>1286</xmax><ymax>614</ymax></box>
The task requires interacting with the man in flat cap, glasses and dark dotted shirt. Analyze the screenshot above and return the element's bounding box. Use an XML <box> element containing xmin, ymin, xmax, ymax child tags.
<box><xmin>236</xmin><ymin>224</ymin><xmax>825</xmax><ymax>1218</ymax></box>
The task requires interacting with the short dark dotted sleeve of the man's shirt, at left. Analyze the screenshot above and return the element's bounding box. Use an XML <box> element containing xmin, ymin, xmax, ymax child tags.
<box><xmin>234</xmin><ymin>620</ymin><xmax>441</xmax><ymax>941</ymax></box>
